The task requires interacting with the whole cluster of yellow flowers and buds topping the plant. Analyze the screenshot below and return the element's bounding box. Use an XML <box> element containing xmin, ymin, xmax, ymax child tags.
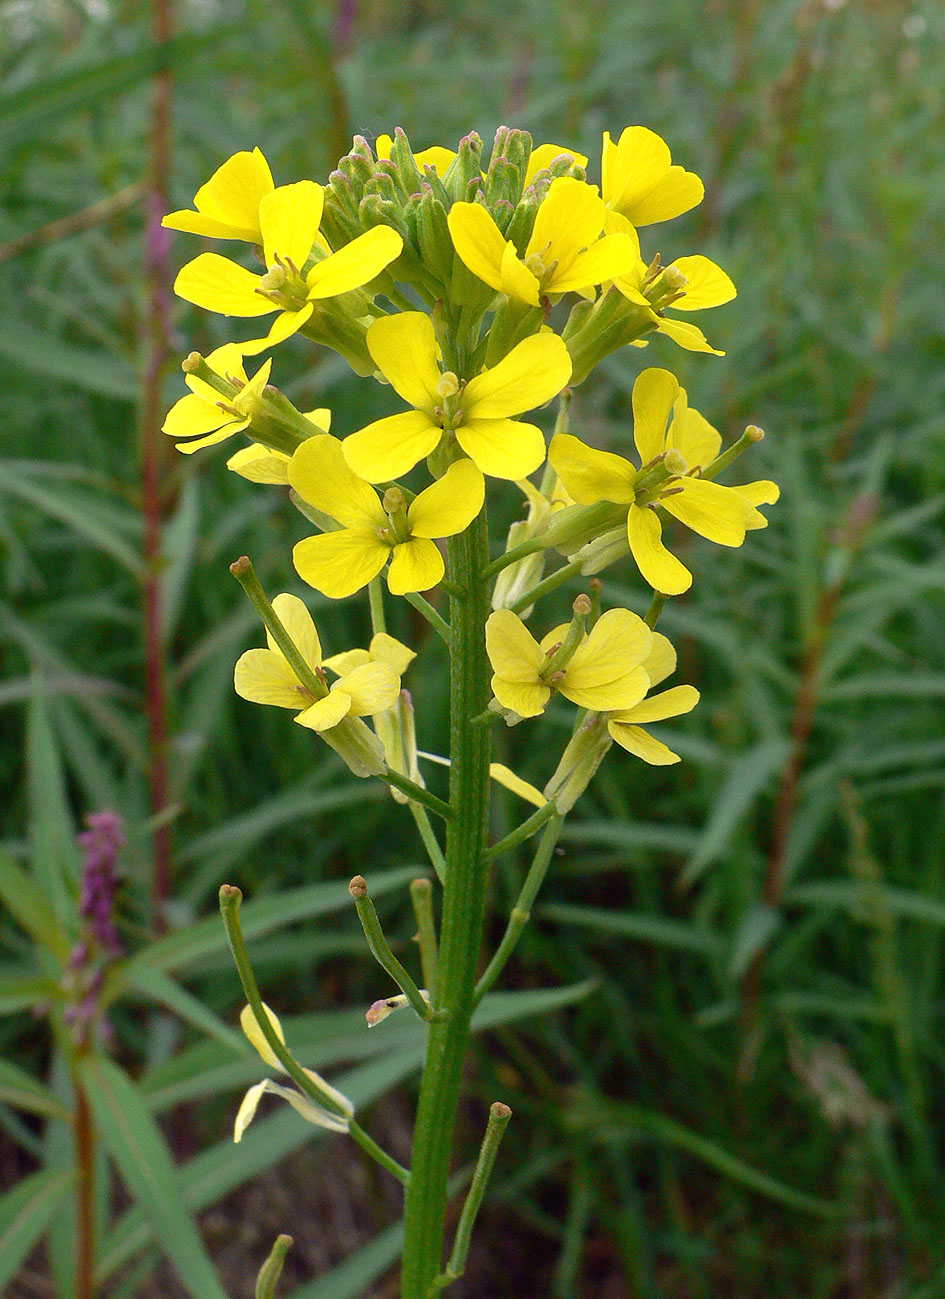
<box><xmin>164</xmin><ymin>126</ymin><xmax>777</xmax><ymax>1130</ymax></box>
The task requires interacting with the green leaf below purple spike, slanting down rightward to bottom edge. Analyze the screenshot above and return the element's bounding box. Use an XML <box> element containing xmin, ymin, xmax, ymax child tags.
<box><xmin>79</xmin><ymin>1056</ymin><xmax>227</xmax><ymax>1299</ymax></box>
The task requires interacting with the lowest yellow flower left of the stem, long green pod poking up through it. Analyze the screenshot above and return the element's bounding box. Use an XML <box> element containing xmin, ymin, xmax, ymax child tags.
<box><xmin>234</xmin><ymin>595</ymin><xmax>400</xmax><ymax>731</ymax></box>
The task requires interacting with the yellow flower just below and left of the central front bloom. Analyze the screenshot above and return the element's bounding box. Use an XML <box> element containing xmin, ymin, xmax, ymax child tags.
<box><xmin>289</xmin><ymin>438</ymin><xmax>485</xmax><ymax>600</ymax></box>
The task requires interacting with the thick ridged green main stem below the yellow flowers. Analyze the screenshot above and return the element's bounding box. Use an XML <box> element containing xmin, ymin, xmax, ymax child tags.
<box><xmin>400</xmin><ymin>509</ymin><xmax>490</xmax><ymax>1299</ymax></box>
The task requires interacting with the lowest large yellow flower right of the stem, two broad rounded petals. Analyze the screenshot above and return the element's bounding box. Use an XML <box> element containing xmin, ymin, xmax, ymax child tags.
<box><xmin>486</xmin><ymin>609</ymin><xmax>653</xmax><ymax>717</ymax></box>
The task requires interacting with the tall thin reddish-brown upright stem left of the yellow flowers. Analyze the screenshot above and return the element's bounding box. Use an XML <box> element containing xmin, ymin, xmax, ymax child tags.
<box><xmin>140</xmin><ymin>0</ymin><xmax>173</xmax><ymax>930</ymax></box>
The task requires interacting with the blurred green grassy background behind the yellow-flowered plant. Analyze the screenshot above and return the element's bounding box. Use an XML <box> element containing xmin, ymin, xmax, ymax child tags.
<box><xmin>0</xmin><ymin>0</ymin><xmax>945</xmax><ymax>1299</ymax></box>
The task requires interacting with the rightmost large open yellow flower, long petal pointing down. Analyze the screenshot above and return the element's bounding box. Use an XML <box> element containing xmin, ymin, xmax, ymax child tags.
<box><xmin>549</xmin><ymin>369</ymin><xmax>779</xmax><ymax>595</ymax></box>
